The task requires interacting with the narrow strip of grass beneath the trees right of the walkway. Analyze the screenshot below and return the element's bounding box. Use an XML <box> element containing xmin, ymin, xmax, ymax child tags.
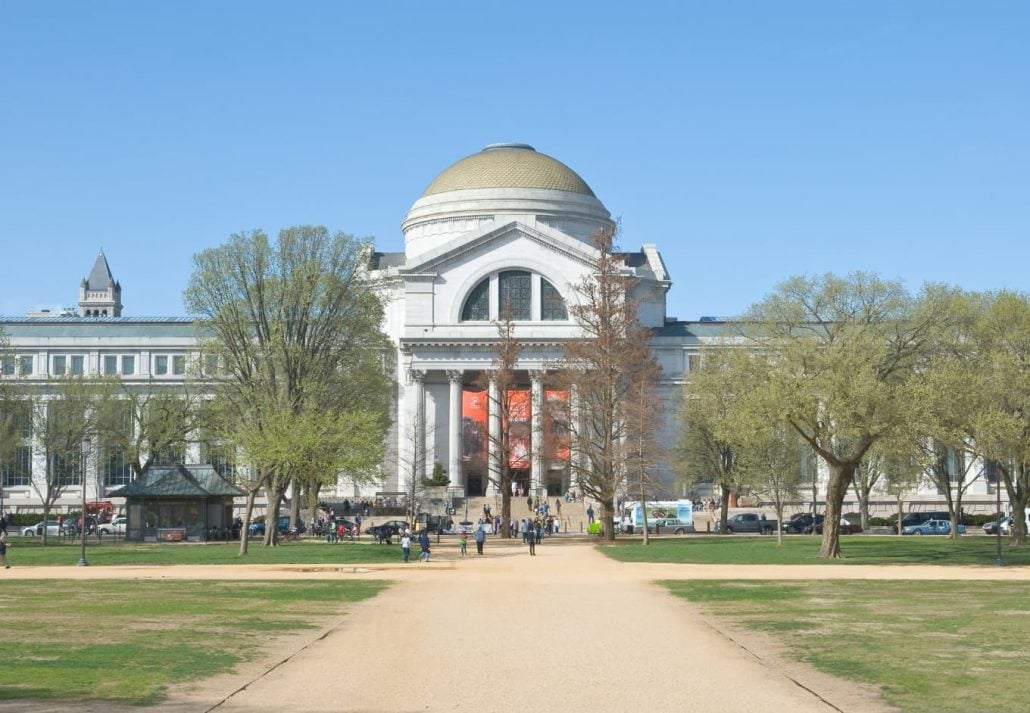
<box><xmin>602</xmin><ymin>535</ymin><xmax>1030</xmax><ymax>566</ymax></box>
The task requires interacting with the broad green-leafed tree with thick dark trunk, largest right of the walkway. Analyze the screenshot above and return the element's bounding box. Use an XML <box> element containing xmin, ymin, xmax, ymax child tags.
<box><xmin>740</xmin><ymin>273</ymin><xmax>949</xmax><ymax>557</ymax></box>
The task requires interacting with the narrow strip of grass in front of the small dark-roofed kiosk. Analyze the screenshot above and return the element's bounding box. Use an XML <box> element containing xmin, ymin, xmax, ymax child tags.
<box><xmin>7</xmin><ymin>537</ymin><xmax>409</xmax><ymax>567</ymax></box>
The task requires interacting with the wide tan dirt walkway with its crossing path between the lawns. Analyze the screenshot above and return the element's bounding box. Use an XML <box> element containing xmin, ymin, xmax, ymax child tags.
<box><xmin>0</xmin><ymin>543</ymin><xmax>1030</xmax><ymax>713</ymax></box>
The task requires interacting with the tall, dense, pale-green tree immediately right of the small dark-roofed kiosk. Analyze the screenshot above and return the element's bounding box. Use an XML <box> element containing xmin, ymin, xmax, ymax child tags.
<box><xmin>185</xmin><ymin>226</ymin><xmax>391</xmax><ymax>554</ymax></box>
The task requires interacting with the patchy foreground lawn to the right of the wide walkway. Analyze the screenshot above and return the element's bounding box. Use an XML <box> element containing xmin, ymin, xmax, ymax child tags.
<box><xmin>662</xmin><ymin>581</ymin><xmax>1030</xmax><ymax>713</ymax></box>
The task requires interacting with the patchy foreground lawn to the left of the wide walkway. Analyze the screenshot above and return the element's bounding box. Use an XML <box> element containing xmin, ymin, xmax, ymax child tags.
<box><xmin>0</xmin><ymin>580</ymin><xmax>387</xmax><ymax>706</ymax></box>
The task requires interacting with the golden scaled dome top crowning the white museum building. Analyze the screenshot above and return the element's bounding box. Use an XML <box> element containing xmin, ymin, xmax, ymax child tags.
<box><xmin>422</xmin><ymin>143</ymin><xmax>593</xmax><ymax>198</ymax></box>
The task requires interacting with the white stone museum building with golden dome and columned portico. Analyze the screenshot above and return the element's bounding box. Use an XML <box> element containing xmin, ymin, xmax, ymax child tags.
<box><xmin>0</xmin><ymin>143</ymin><xmax>997</xmax><ymax>510</ymax></box>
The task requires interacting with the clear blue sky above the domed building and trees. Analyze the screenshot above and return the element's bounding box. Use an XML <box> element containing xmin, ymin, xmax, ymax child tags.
<box><xmin>0</xmin><ymin>0</ymin><xmax>1030</xmax><ymax>319</ymax></box>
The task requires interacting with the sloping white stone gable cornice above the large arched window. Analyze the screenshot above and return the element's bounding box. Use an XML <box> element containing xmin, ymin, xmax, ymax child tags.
<box><xmin>401</xmin><ymin>220</ymin><xmax>597</xmax><ymax>274</ymax></box>
